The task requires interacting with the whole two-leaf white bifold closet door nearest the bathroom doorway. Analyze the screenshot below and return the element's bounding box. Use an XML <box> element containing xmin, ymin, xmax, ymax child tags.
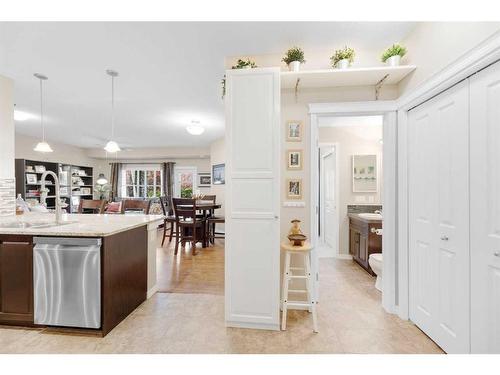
<box><xmin>408</xmin><ymin>80</ymin><xmax>470</xmax><ymax>353</ymax></box>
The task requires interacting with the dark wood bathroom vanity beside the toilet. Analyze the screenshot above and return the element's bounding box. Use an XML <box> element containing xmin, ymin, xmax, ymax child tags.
<box><xmin>348</xmin><ymin>213</ymin><xmax>382</xmax><ymax>276</ymax></box>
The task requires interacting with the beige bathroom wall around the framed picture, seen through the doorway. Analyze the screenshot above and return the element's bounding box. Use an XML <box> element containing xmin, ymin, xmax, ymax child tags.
<box><xmin>319</xmin><ymin>125</ymin><xmax>383</xmax><ymax>254</ymax></box>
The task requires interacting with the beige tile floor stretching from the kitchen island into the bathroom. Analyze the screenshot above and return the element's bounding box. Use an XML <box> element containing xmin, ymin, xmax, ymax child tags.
<box><xmin>0</xmin><ymin>234</ymin><xmax>442</xmax><ymax>353</ymax></box>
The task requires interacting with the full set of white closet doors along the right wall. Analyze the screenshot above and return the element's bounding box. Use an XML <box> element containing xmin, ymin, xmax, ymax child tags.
<box><xmin>408</xmin><ymin>63</ymin><xmax>500</xmax><ymax>353</ymax></box>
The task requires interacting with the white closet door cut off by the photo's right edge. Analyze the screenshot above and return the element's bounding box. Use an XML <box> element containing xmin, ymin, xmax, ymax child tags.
<box><xmin>470</xmin><ymin>63</ymin><xmax>500</xmax><ymax>353</ymax></box>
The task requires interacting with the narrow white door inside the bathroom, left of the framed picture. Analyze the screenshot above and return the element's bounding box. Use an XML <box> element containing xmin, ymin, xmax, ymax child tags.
<box><xmin>318</xmin><ymin>143</ymin><xmax>339</xmax><ymax>258</ymax></box>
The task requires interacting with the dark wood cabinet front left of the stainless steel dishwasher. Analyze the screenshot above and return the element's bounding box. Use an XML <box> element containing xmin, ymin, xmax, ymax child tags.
<box><xmin>0</xmin><ymin>235</ymin><xmax>33</xmax><ymax>325</ymax></box>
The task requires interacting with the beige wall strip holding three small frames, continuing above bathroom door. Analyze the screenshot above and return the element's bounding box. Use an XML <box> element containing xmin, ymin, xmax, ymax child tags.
<box><xmin>280</xmin><ymin>86</ymin><xmax>397</xmax><ymax>238</ymax></box>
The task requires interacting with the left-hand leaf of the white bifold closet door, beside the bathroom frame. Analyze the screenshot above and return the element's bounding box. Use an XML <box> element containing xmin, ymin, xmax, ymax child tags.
<box><xmin>408</xmin><ymin>104</ymin><xmax>437</xmax><ymax>337</ymax></box>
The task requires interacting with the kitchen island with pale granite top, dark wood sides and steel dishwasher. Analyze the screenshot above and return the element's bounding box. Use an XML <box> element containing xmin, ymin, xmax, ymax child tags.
<box><xmin>0</xmin><ymin>213</ymin><xmax>163</xmax><ymax>336</ymax></box>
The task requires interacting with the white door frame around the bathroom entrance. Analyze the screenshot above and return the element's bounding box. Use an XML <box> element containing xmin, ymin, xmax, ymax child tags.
<box><xmin>309</xmin><ymin>100</ymin><xmax>398</xmax><ymax>313</ymax></box>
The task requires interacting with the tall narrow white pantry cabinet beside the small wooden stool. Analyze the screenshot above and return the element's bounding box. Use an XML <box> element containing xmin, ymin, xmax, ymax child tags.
<box><xmin>225</xmin><ymin>68</ymin><xmax>280</xmax><ymax>330</ymax></box>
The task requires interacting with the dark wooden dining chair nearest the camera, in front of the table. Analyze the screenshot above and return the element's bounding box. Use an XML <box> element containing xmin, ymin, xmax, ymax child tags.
<box><xmin>172</xmin><ymin>198</ymin><xmax>205</xmax><ymax>255</ymax></box>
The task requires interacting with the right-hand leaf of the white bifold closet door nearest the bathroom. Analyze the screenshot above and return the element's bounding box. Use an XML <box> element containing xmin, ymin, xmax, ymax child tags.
<box><xmin>434</xmin><ymin>81</ymin><xmax>470</xmax><ymax>353</ymax></box>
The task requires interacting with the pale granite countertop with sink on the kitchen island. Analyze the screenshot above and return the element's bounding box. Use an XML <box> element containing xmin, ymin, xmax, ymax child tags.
<box><xmin>0</xmin><ymin>212</ymin><xmax>163</xmax><ymax>237</ymax></box>
